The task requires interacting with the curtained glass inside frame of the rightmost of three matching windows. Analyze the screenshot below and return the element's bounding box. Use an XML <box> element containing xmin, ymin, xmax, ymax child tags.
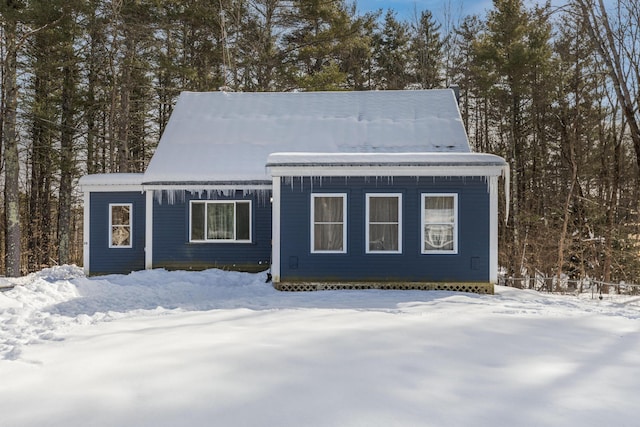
<box><xmin>424</xmin><ymin>196</ymin><xmax>455</xmax><ymax>251</ymax></box>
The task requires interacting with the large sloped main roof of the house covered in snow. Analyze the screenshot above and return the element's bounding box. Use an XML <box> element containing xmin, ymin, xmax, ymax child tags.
<box><xmin>143</xmin><ymin>89</ymin><xmax>470</xmax><ymax>184</ymax></box>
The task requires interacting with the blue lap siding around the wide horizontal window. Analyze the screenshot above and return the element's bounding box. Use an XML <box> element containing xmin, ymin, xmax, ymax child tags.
<box><xmin>153</xmin><ymin>192</ymin><xmax>271</xmax><ymax>271</ymax></box>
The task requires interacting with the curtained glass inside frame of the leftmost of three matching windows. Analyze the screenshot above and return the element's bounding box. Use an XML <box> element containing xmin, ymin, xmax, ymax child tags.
<box><xmin>313</xmin><ymin>197</ymin><xmax>344</xmax><ymax>251</ymax></box>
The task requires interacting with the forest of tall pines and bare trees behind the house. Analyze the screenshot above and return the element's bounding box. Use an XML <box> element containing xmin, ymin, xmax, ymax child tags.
<box><xmin>0</xmin><ymin>0</ymin><xmax>640</xmax><ymax>283</ymax></box>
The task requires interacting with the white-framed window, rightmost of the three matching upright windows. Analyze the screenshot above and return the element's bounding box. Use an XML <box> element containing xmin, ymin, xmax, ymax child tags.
<box><xmin>422</xmin><ymin>194</ymin><xmax>458</xmax><ymax>254</ymax></box>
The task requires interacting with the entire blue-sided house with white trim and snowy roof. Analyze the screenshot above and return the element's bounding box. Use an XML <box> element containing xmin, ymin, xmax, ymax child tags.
<box><xmin>80</xmin><ymin>89</ymin><xmax>509</xmax><ymax>293</ymax></box>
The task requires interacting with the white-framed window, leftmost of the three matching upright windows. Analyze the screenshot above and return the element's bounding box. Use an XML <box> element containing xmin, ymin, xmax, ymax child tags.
<box><xmin>311</xmin><ymin>194</ymin><xmax>347</xmax><ymax>253</ymax></box>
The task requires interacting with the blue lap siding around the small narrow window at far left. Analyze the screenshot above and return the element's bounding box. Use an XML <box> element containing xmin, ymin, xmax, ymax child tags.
<box><xmin>89</xmin><ymin>191</ymin><xmax>145</xmax><ymax>274</ymax></box>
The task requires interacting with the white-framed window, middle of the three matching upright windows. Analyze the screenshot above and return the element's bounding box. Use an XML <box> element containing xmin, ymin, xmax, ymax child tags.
<box><xmin>366</xmin><ymin>194</ymin><xmax>402</xmax><ymax>253</ymax></box>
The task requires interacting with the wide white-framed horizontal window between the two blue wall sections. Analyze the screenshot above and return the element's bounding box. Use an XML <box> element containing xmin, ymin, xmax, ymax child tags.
<box><xmin>190</xmin><ymin>200</ymin><xmax>251</xmax><ymax>242</ymax></box>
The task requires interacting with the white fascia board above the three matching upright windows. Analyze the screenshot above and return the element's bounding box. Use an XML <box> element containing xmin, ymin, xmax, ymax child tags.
<box><xmin>270</xmin><ymin>165</ymin><xmax>504</xmax><ymax>177</ymax></box>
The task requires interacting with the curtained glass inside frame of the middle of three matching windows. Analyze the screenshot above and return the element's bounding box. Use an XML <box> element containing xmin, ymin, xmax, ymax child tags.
<box><xmin>369</xmin><ymin>197</ymin><xmax>399</xmax><ymax>251</ymax></box>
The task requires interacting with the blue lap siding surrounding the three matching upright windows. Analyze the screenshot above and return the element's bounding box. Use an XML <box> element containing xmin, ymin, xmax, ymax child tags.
<box><xmin>281</xmin><ymin>177</ymin><xmax>489</xmax><ymax>282</ymax></box>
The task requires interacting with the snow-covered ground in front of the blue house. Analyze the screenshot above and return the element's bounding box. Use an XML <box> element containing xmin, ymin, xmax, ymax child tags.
<box><xmin>0</xmin><ymin>266</ymin><xmax>640</xmax><ymax>427</ymax></box>
